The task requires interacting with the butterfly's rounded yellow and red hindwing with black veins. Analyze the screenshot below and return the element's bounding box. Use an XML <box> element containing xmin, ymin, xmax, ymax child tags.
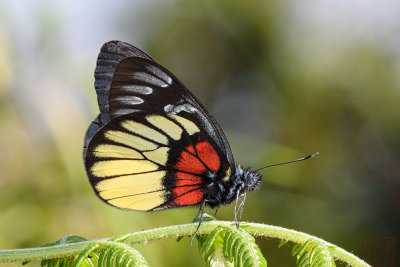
<box><xmin>85</xmin><ymin>112</ymin><xmax>230</xmax><ymax>211</ymax></box>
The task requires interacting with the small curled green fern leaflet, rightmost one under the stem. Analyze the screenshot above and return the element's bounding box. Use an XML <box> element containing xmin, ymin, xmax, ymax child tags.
<box><xmin>292</xmin><ymin>239</ymin><xmax>336</xmax><ymax>267</ymax></box>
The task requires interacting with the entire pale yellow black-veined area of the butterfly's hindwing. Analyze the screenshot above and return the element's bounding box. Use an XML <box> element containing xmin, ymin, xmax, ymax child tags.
<box><xmin>86</xmin><ymin>115</ymin><xmax>181</xmax><ymax>211</ymax></box>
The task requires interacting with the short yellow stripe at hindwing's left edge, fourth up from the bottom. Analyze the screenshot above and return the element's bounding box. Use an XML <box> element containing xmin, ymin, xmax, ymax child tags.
<box><xmin>93</xmin><ymin>144</ymin><xmax>143</xmax><ymax>159</ymax></box>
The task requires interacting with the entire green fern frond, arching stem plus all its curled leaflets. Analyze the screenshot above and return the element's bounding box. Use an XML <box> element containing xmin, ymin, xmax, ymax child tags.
<box><xmin>6</xmin><ymin>223</ymin><xmax>371</xmax><ymax>267</ymax></box>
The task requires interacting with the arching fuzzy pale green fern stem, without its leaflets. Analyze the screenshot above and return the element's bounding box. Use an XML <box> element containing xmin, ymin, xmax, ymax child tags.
<box><xmin>0</xmin><ymin>221</ymin><xmax>370</xmax><ymax>267</ymax></box>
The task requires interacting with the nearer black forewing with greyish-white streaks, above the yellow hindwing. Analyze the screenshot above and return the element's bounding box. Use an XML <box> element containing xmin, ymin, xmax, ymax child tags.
<box><xmin>109</xmin><ymin>57</ymin><xmax>234</xmax><ymax>169</ymax></box>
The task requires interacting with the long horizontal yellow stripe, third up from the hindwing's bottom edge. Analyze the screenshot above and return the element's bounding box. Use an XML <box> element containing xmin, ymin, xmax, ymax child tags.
<box><xmin>90</xmin><ymin>159</ymin><xmax>158</xmax><ymax>178</ymax></box>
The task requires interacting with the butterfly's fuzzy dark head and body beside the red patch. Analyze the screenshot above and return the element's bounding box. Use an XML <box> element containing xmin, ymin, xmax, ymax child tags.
<box><xmin>206</xmin><ymin>165</ymin><xmax>262</xmax><ymax>208</ymax></box>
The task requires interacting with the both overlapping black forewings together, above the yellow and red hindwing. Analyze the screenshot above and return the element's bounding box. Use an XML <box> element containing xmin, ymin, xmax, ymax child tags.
<box><xmin>84</xmin><ymin>41</ymin><xmax>235</xmax><ymax>170</ymax></box>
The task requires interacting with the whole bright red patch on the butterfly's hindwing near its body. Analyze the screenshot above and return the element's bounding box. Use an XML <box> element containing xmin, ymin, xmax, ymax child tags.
<box><xmin>172</xmin><ymin>141</ymin><xmax>221</xmax><ymax>206</ymax></box>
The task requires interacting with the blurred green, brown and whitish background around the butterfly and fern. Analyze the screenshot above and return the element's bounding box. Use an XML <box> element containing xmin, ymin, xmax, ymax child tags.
<box><xmin>0</xmin><ymin>0</ymin><xmax>400</xmax><ymax>266</ymax></box>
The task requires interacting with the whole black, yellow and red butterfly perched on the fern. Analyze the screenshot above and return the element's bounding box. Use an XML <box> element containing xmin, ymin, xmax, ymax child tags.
<box><xmin>83</xmin><ymin>41</ymin><xmax>316</xmax><ymax>232</ymax></box>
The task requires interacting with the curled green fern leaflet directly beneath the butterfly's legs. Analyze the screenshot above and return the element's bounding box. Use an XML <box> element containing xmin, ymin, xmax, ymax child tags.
<box><xmin>197</xmin><ymin>226</ymin><xmax>267</xmax><ymax>267</ymax></box>
